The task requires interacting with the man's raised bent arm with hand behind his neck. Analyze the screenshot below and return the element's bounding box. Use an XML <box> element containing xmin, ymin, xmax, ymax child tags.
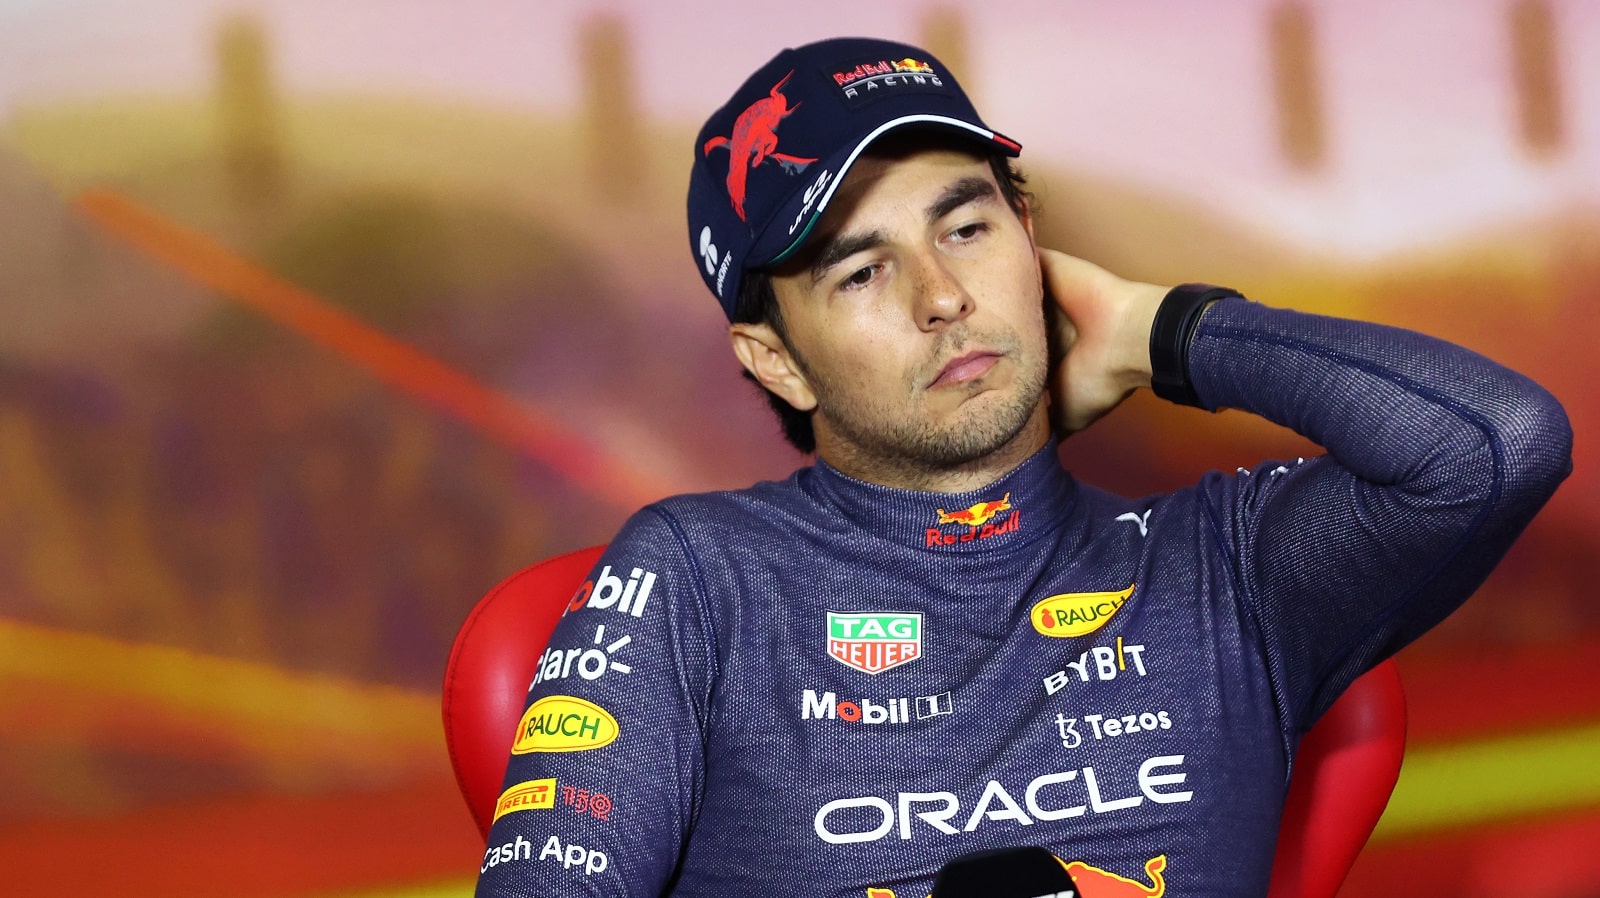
<box><xmin>1046</xmin><ymin>248</ymin><xmax>1571</xmax><ymax>730</ymax></box>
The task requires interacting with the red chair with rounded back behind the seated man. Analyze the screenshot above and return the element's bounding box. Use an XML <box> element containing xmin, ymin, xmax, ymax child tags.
<box><xmin>443</xmin><ymin>546</ymin><xmax>1405</xmax><ymax>898</ymax></box>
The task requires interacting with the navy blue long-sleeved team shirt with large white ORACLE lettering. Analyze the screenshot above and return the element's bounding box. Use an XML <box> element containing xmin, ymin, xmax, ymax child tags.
<box><xmin>477</xmin><ymin>299</ymin><xmax>1571</xmax><ymax>898</ymax></box>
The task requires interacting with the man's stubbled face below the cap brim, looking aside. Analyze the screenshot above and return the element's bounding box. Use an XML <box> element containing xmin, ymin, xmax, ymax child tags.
<box><xmin>745</xmin><ymin>149</ymin><xmax>1048</xmax><ymax>482</ymax></box>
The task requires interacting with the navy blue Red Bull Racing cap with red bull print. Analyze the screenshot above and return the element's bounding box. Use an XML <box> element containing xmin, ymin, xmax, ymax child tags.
<box><xmin>688</xmin><ymin>37</ymin><xmax>1022</xmax><ymax>320</ymax></box>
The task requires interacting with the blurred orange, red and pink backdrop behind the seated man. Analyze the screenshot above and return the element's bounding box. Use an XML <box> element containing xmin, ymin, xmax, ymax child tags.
<box><xmin>0</xmin><ymin>0</ymin><xmax>1600</xmax><ymax>898</ymax></box>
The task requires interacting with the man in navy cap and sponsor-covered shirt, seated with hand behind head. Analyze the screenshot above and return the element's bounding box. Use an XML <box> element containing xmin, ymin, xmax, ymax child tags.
<box><xmin>478</xmin><ymin>40</ymin><xmax>1571</xmax><ymax>898</ymax></box>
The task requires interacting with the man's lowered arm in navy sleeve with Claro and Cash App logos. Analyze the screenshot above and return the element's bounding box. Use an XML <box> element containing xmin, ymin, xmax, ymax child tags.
<box><xmin>477</xmin><ymin>509</ymin><xmax>714</xmax><ymax>898</ymax></box>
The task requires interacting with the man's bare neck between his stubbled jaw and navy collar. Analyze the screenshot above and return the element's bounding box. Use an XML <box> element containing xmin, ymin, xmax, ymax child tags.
<box><xmin>816</xmin><ymin>402</ymin><xmax>1050</xmax><ymax>493</ymax></box>
